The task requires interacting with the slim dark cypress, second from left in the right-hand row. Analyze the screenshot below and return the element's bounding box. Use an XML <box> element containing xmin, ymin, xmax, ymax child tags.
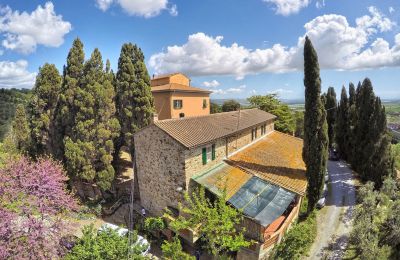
<box><xmin>335</xmin><ymin>86</ymin><xmax>350</xmax><ymax>160</ymax></box>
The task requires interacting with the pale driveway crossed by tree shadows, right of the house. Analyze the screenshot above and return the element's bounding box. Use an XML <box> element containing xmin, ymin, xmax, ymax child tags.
<box><xmin>306</xmin><ymin>161</ymin><xmax>356</xmax><ymax>259</ymax></box>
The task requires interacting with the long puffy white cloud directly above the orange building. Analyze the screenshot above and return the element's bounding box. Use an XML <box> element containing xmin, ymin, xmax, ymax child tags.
<box><xmin>149</xmin><ymin>33</ymin><xmax>296</xmax><ymax>78</ymax></box>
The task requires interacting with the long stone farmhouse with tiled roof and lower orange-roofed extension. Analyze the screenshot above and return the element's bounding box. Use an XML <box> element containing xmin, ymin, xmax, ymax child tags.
<box><xmin>134</xmin><ymin>106</ymin><xmax>307</xmax><ymax>259</ymax></box>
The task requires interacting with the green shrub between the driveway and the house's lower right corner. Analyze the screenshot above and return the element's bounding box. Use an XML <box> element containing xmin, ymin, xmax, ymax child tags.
<box><xmin>272</xmin><ymin>212</ymin><xmax>317</xmax><ymax>260</ymax></box>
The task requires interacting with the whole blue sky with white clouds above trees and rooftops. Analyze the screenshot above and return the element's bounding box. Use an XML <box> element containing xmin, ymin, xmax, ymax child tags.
<box><xmin>0</xmin><ymin>0</ymin><xmax>400</xmax><ymax>99</ymax></box>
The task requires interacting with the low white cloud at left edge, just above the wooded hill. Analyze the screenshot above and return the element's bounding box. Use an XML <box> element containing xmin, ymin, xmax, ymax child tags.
<box><xmin>0</xmin><ymin>60</ymin><xmax>36</xmax><ymax>88</ymax></box>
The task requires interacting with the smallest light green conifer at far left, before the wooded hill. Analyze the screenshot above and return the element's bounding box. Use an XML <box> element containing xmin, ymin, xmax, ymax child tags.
<box><xmin>12</xmin><ymin>104</ymin><xmax>31</xmax><ymax>153</ymax></box>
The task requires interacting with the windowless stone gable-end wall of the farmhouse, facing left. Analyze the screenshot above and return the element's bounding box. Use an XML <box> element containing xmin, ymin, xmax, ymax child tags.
<box><xmin>135</xmin><ymin>125</ymin><xmax>186</xmax><ymax>216</ymax></box>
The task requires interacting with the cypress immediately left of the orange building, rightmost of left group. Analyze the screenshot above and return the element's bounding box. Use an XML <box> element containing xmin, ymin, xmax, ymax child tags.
<box><xmin>114</xmin><ymin>43</ymin><xmax>154</xmax><ymax>160</ymax></box>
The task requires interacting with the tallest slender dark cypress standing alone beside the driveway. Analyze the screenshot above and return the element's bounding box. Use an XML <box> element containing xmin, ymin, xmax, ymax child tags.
<box><xmin>303</xmin><ymin>37</ymin><xmax>328</xmax><ymax>212</ymax></box>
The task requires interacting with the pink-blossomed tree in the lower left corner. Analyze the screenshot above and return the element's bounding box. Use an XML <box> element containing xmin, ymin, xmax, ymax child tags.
<box><xmin>0</xmin><ymin>157</ymin><xmax>77</xmax><ymax>259</ymax></box>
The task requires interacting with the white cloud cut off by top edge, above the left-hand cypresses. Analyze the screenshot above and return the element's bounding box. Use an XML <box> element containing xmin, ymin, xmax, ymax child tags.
<box><xmin>96</xmin><ymin>0</ymin><xmax>178</xmax><ymax>18</ymax></box>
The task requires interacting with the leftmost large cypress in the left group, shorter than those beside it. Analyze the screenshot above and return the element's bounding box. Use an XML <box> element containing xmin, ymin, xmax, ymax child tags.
<box><xmin>28</xmin><ymin>63</ymin><xmax>61</xmax><ymax>156</ymax></box>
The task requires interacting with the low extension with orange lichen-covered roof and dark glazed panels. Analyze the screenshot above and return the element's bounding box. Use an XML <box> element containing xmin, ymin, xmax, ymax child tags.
<box><xmin>193</xmin><ymin>131</ymin><xmax>307</xmax><ymax>255</ymax></box>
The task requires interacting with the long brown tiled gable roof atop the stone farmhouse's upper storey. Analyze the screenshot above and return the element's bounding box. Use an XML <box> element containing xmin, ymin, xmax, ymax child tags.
<box><xmin>154</xmin><ymin>109</ymin><xmax>276</xmax><ymax>148</ymax></box>
